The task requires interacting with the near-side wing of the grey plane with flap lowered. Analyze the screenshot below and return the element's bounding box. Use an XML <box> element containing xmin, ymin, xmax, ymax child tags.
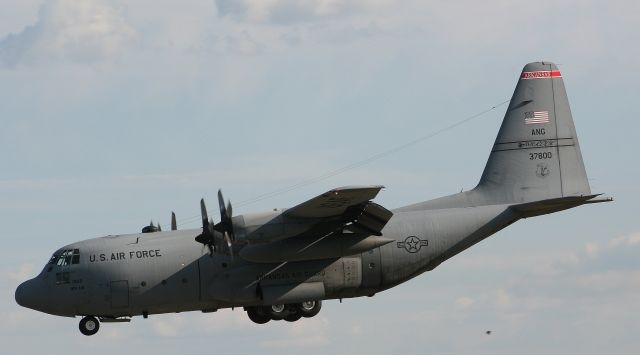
<box><xmin>239</xmin><ymin>186</ymin><xmax>393</xmax><ymax>265</ymax></box>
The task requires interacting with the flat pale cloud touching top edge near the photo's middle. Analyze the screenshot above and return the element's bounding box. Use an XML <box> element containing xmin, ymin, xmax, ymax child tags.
<box><xmin>216</xmin><ymin>0</ymin><xmax>389</xmax><ymax>25</ymax></box>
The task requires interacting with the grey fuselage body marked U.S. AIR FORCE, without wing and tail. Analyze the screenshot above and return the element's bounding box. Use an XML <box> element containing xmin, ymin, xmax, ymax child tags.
<box><xmin>20</xmin><ymin>200</ymin><xmax>518</xmax><ymax>317</ymax></box>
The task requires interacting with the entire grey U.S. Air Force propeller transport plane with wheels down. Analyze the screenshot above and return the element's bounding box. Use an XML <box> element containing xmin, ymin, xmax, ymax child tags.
<box><xmin>15</xmin><ymin>62</ymin><xmax>611</xmax><ymax>335</ymax></box>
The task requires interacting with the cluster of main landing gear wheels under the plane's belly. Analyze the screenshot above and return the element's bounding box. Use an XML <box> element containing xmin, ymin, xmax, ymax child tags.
<box><xmin>245</xmin><ymin>301</ymin><xmax>322</xmax><ymax>324</ymax></box>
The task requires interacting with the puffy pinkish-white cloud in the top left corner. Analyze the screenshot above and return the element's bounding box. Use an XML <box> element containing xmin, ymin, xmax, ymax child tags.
<box><xmin>0</xmin><ymin>0</ymin><xmax>139</xmax><ymax>67</ymax></box>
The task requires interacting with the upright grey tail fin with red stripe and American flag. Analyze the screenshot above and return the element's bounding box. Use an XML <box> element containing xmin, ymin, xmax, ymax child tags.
<box><xmin>476</xmin><ymin>62</ymin><xmax>591</xmax><ymax>203</ymax></box>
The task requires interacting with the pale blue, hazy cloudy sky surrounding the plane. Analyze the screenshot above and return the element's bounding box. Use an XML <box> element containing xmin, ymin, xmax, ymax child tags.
<box><xmin>0</xmin><ymin>0</ymin><xmax>640</xmax><ymax>354</ymax></box>
